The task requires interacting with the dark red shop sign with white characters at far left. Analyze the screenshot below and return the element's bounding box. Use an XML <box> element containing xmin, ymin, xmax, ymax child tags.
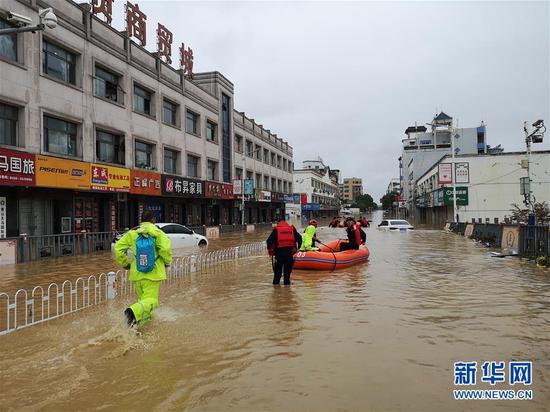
<box><xmin>0</xmin><ymin>149</ymin><xmax>36</xmax><ymax>186</ymax></box>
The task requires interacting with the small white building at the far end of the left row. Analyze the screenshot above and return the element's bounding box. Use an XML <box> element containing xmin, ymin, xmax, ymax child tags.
<box><xmin>293</xmin><ymin>158</ymin><xmax>340</xmax><ymax>217</ymax></box>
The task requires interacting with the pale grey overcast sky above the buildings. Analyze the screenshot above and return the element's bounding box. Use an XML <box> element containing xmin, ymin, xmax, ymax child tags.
<box><xmin>106</xmin><ymin>0</ymin><xmax>550</xmax><ymax>202</ymax></box>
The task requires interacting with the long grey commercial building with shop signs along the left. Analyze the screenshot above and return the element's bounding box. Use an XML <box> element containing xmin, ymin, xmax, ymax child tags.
<box><xmin>0</xmin><ymin>0</ymin><xmax>293</xmax><ymax>236</ymax></box>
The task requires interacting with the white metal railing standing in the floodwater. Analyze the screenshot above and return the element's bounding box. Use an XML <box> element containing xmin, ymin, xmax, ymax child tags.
<box><xmin>0</xmin><ymin>242</ymin><xmax>266</xmax><ymax>336</ymax></box>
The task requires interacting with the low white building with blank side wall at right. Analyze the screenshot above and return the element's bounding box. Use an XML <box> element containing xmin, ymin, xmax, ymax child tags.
<box><xmin>415</xmin><ymin>150</ymin><xmax>550</xmax><ymax>225</ymax></box>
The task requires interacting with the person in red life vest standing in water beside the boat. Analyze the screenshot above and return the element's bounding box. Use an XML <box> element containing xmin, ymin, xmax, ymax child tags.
<box><xmin>266</xmin><ymin>217</ymin><xmax>302</xmax><ymax>285</ymax></box>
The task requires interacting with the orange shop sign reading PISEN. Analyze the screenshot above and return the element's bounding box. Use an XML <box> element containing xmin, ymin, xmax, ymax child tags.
<box><xmin>36</xmin><ymin>155</ymin><xmax>90</xmax><ymax>190</ymax></box>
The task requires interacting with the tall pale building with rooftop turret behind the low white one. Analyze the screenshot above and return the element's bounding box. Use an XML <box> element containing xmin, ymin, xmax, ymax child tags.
<box><xmin>399</xmin><ymin>112</ymin><xmax>487</xmax><ymax>217</ymax></box>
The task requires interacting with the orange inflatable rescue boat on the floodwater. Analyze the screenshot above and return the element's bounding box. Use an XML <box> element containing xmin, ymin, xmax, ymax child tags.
<box><xmin>294</xmin><ymin>239</ymin><xmax>370</xmax><ymax>270</ymax></box>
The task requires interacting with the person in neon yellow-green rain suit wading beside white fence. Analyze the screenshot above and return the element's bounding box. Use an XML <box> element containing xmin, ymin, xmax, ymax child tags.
<box><xmin>115</xmin><ymin>210</ymin><xmax>172</xmax><ymax>327</ymax></box>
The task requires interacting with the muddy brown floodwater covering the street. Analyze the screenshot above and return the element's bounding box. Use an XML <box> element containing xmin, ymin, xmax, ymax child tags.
<box><xmin>0</xmin><ymin>217</ymin><xmax>550</xmax><ymax>411</ymax></box>
